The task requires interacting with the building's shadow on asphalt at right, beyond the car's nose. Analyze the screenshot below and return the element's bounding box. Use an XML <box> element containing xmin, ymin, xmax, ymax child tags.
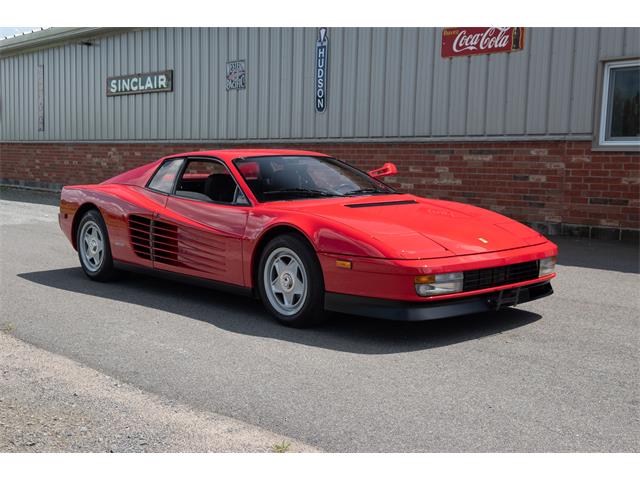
<box><xmin>549</xmin><ymin>237</ymin><xmax>640</xmax><ymax>273</ymax></box>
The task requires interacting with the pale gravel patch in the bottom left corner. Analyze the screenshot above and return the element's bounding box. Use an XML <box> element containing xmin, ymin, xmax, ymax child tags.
<box><xmin>0</xmin><ymin>332</ymin><xmax>315</xmax><ymax>452</ymax></box>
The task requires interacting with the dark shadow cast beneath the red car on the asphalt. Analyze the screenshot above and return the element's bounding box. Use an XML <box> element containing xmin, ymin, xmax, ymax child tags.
<box><xmin>18</xmin><ymin>268</ymin><xmax>541</xmax><ymax>354</ymax></box>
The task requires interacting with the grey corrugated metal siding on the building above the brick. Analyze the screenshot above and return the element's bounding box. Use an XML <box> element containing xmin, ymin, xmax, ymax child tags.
<box><xmin>0</xmin><ymin>28</ymin><xmax>640</xmax><ymax>142</ymax></box>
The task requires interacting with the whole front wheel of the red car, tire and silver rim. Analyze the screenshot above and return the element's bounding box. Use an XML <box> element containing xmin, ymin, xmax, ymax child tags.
<box><xmin>257</xmin><ymin>234</ymin><xmax>325</xmax><ymax>328</ymax></box>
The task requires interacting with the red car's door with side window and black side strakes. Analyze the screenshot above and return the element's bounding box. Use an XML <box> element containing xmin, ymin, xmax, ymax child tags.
<box><xmin>153</xmin><ymin>158</ymin><xmax>251</xmax><ymax>285</ymax></box>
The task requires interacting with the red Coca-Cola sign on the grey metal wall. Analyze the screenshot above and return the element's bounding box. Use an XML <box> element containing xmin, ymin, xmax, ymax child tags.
<box><xmin>442</xmin><ymin>27</ymin><xmax>524</xmax><ymax>57</ymax></box>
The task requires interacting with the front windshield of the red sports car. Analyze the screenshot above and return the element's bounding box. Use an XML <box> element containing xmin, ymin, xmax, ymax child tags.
<box><xmin>234</xmin><ymin>155</ymin><xmax>395</xmax><ymax>202</ymax></box>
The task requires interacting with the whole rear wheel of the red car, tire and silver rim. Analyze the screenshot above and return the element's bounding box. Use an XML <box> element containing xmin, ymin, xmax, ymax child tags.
<box><xmin>76</xmin><ymin>206</ymin><xmax>116</xmax><ymax>282</ymax></box>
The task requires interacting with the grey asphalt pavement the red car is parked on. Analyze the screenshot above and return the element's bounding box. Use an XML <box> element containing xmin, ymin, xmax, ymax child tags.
<box><xmin>0</xmin><ymin>189</ymin><xmax>640</xmax><ymax>452</ymax></box>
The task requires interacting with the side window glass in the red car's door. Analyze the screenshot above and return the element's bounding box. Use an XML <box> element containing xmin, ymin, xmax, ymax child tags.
<box><xmin>176</xmin><ymin>159</ymin><xmax>248</xmax><ymax>205</ymax></box>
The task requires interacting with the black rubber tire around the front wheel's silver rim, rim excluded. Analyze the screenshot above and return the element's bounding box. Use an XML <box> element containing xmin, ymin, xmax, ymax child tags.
<box><xmin>257</xmin><ymin>234</ymin><xmax>324</xmax><ymax>328</ymax></box>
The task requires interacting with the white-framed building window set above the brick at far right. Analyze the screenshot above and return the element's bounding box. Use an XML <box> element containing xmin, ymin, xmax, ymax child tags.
<box><xmin>598</xmin><ymin>60</ymin><xmax>640</xmax><ymax>147</ymax></box>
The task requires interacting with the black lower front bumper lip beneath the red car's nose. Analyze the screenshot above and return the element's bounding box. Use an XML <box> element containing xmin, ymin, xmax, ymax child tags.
<box><xmin>324</xmin><ymin>280</ymin><xmax>553</xmax><ymax>321</ymax></box>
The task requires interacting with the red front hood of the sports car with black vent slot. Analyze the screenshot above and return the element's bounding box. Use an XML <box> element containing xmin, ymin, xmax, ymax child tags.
<box><xmin>274</xmin><ymin>195</ymin><xmax>546</xmax><ymax>259</ymax></box>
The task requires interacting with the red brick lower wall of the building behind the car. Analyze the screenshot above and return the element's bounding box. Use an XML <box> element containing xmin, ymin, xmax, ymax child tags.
<box><xmin>0</xmin><ymin>141</ymin><xmax>640</xmax><ymax>236</ymax></box>
